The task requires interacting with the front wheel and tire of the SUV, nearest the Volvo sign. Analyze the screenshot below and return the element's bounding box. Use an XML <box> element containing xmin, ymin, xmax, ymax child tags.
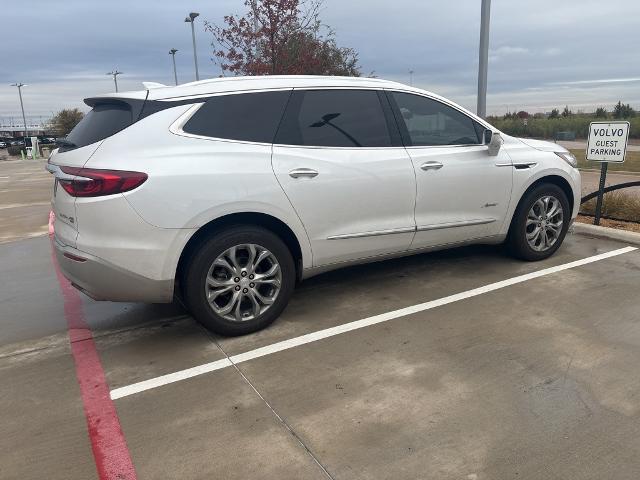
<box><xmin>507</xmin><ymin>183</ymin><xmax>571</xmax><ymax>261</ymax></box>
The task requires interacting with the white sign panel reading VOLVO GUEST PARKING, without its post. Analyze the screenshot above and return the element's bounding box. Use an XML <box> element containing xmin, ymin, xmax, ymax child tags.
<box><xmin>587</xmin><ymin>122</ymin><xmax>629</xmax><ymax>163</ymax></box>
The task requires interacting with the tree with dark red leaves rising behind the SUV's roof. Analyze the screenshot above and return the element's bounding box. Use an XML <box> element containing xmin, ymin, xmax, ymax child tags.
<box><xmin>205</xmin><ymin>0</ymin><xmax>360</xmax><ymax>77</ymax></box>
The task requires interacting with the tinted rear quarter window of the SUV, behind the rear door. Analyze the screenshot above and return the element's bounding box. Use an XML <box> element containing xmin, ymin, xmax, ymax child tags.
<box><xmin>182</xmin><ymin>91</ymin><xmax>291</xmax><ymax>143</ymax></box>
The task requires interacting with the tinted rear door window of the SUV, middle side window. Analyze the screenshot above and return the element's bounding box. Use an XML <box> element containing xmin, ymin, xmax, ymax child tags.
<box><xmin>275</xmin><ymin>90</ymin><xmax>391</xmax><ymax>147</ymax></box>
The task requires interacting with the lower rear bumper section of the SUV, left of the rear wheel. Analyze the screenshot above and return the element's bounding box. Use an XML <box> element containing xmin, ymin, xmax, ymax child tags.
<box><xmin>54</xmin><ymin>240</ymin><xmax>173</xmax><ymax>303</ymax></box>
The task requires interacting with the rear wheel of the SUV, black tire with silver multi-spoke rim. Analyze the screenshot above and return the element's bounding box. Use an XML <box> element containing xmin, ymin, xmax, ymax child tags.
<box><xmin>183</xmin><ymin>225</ymin><xmax>296</xmax><ymax>336</ymax></box>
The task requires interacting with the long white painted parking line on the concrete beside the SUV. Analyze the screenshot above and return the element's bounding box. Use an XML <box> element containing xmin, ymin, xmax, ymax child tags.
<box><xmin>111</xmin><ymin>247</ymin><xmax>637</xmax><ymax>400</ymax></box>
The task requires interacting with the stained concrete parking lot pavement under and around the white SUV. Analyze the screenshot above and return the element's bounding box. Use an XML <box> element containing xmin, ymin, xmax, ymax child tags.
<box><xmin>0</xmin><ymin>223</ymin><xmax>640</xmax><ymax>479</ymax></box>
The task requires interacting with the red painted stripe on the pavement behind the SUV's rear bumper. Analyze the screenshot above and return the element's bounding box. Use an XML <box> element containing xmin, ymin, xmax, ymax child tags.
<box><xmin>49</xmin><ymin>216</ymin><xmax>137</xmax><ymax>480</ymax></box>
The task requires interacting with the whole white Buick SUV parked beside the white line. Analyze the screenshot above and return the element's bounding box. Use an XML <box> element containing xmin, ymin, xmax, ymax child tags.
<box><xmin>47</xmin><ymin>76</ymin><xmax>580</xmax><ymax>335</ymax></box>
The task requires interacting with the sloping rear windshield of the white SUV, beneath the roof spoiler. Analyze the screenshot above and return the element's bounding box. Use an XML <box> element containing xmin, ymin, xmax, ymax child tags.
<box><xmin>66</xmin><ymin>103</ymin><xmax>133</xmax><ymax>148</ymax></box>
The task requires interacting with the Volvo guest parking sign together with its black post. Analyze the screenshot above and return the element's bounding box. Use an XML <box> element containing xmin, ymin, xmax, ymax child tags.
<box><xmin>587</xmin><ymin>122</ymin><xmax>629</xmax><ymax>225</ymax></box>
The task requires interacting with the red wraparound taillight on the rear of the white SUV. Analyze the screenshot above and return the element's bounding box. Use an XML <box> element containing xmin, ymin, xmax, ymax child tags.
<box><xmin>58</xmin><ymin>167</ymin><xmax>147</xmax><ymax>197</ymax></box>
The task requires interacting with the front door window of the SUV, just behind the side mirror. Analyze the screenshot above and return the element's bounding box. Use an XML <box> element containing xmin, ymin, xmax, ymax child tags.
<box><xmin>391</xmin><ymin>92</ymin><xmax>483</xmax><ymax>146</ymax></box>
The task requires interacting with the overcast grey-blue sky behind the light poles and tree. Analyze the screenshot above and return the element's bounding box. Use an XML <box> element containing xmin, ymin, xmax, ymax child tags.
<box><xmin>0</xmin><ymin>0</ymin><xmax>640</xmax><ymax>123</ymax></box>
